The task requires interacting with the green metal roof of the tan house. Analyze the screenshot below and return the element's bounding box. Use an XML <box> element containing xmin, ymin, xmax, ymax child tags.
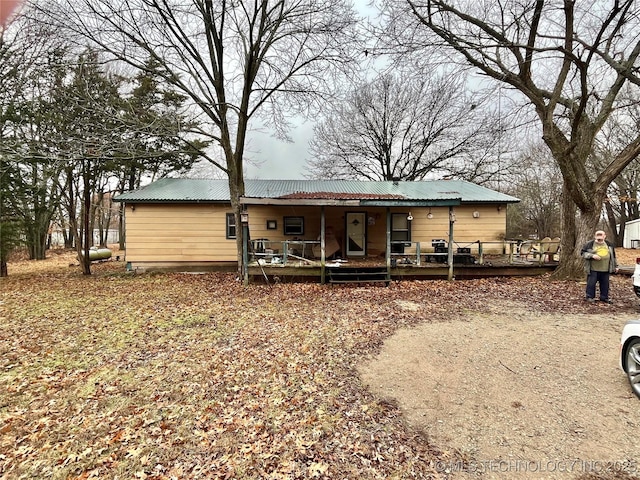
<box><xmin>115</xmin><ymin>178</ymin><xmax>520</xmax><ymax>204</ymax></box>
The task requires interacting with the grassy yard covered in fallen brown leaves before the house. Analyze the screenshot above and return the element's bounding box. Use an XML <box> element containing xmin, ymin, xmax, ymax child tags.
<box><xmin>0</xmin><ymin>251</ymin><xmax>637</xmax><ymax>479</ymax></box>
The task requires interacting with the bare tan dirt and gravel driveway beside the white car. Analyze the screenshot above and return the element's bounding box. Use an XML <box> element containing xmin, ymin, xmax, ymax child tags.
<box><xmin>359</xmin><ymin>300</ymin><xmax>640</xmax><ymax>479</ymax></box>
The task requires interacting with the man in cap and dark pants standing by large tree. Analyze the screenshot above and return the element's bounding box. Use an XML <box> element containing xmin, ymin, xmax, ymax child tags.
<box><xmin>580</xmin><ymin>230</ymin><xmax>618</xmax><ymax>303</ymax></box>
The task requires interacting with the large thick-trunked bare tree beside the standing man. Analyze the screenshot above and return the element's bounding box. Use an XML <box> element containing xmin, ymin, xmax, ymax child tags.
<box><xmin>385</xmin><ymin>0</ymin><xmax>640</xmax><ymax>277</ymax></box>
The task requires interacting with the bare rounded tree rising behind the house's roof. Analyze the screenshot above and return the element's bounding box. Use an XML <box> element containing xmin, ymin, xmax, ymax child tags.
<box><xmin>309</xmin><ymin>72</ymin><xmax>498</xmax><ymax>181</ymax></box>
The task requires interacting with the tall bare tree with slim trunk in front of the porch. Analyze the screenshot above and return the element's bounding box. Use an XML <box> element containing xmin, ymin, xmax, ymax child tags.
<box><xmin>31</xmin><ymin>0</ymin><xmax>362</xmax><ymax>280</ymax></box>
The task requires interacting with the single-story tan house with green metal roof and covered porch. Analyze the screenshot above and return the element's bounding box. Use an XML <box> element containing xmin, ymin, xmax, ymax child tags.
<box><xmin>115</xmin><ymin>178</ymin><xmax>519</xmax><ymax>280</ymax></box>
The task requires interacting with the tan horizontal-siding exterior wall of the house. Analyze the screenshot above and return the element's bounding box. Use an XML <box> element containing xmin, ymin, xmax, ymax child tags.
<box><xmin>125</xmin><ymin>204</ymin><xmax>506</xmax><ymax>267</ymax></box>
